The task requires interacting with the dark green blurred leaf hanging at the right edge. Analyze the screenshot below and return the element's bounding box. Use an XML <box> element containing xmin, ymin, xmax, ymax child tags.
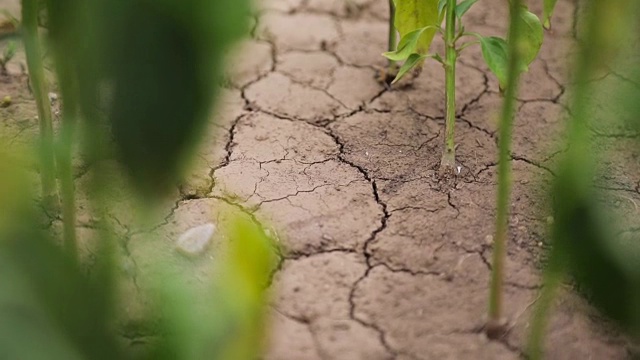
<box><xmin>552</xmin><ymin>162</ymin><xmax>640</xmax><ymax>334</ymax></box>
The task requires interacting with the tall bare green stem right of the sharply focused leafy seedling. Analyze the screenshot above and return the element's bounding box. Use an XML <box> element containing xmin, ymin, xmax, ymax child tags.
<box><xmin>487</xmin><ymin>0</ymin><xmax>523</xmax><ymax>338</ymax></box>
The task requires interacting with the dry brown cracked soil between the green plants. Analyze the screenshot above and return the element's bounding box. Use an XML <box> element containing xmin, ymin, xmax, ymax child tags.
<box><xmin>0</xmin><ymin>0</ymin><xmax>640</xmax><ymax>360</ymax></box>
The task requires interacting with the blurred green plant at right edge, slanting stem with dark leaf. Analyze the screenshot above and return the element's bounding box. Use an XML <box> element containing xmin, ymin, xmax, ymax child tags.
<box><xmin>527</xmin><ymin>0</ymin><xmax>640</xmax><ymax>359</ymax></box>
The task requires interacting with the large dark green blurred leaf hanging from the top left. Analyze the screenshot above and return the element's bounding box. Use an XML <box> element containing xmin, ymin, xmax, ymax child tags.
<box><xmin>108</xmin><ymin>0</ymin><xmax>247</xmax><ymax>198</ymax></box>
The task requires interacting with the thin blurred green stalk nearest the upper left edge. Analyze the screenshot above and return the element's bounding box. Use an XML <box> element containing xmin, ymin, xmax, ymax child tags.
<box><xmin>22</xmin><ymin>0</ymin><xmax>58</xmax><ymax>210</ymax></box>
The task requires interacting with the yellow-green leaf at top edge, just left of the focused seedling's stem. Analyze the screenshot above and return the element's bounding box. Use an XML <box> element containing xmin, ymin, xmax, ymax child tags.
<box><xmin>394</xmin><ymin>0</ymin><xmax>439</xmax><ymax>54</ymax></box>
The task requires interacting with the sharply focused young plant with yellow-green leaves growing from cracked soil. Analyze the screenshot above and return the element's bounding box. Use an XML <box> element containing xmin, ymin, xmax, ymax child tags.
<box><xmin>383</xmin><ymin>0</ymin><xmax>543</xmax><ymax>174</ymax></box>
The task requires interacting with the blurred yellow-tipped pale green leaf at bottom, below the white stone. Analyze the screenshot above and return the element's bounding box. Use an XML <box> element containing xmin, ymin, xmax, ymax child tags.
<box><xmin>151</xmin><ymin>217</ymin><xmax>276</xmax><ymax>360</ymax></box>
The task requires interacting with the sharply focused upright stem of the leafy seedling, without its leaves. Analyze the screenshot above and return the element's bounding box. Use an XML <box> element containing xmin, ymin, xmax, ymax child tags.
<box><xmin>440</xmin><ymin>0</ymin><xmax>458</xmax><ymax>171</ymax></box>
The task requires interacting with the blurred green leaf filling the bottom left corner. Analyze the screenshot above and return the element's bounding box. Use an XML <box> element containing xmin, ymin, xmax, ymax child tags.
<box><xmin>0</xmin><ymin>153</ymin><xmax>125</xmax><ymax>360</ymax></box>
